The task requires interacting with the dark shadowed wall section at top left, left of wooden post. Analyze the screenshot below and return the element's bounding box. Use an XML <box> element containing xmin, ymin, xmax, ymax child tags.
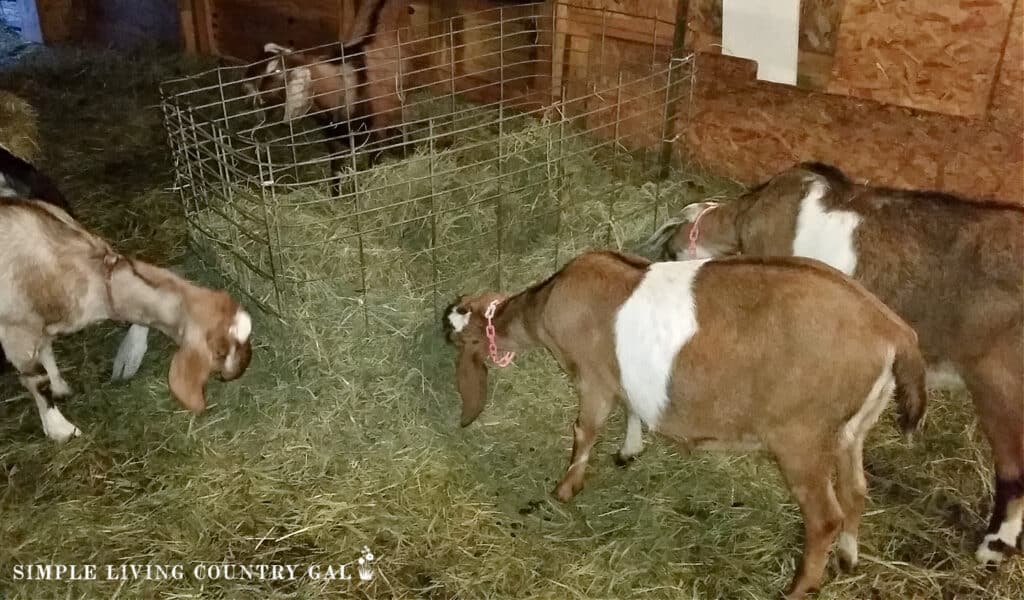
<box><xmin>36</xmin><ymin>0</ymin><xmax>181</xmax><ymax>48</ymax></box>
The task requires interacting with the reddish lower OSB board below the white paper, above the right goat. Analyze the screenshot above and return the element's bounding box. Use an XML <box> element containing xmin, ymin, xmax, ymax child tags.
<box><xmin>685</xmin><ymin>54</ymin><xmax>1024</xmax><ymax>204</ymax></box>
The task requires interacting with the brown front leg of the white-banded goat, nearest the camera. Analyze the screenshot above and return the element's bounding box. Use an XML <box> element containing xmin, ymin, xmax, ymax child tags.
<box><xmin>555</xmin><ymin>376</ymin><xmax>615</xmax><ymax>502</ymax></box>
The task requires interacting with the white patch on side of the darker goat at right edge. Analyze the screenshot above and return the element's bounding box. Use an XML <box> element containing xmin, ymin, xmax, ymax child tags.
<box><xmin>793</xmin><ymin>176</ymin><xmax>861</xmax><ymax>276</ymax></box>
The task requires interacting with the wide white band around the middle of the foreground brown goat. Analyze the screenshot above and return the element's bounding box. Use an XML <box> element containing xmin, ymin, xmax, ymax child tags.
<box><xmin>614</xmin><ymin>260</ymin><xmax>708</xmax><ymax>429</ymax></box>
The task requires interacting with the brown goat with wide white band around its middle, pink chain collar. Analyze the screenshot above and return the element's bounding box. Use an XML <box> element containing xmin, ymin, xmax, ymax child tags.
<box><xmin>444</xmin><ymin>252</ymin><xmax>926</xmax><ymax>598</ymax></box>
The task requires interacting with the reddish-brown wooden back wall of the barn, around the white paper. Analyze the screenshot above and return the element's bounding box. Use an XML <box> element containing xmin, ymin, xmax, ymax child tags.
<box><xmin>172</xmin><ymin>0</ymin><xmax>1024</xmax><ymax>204</ymax></box>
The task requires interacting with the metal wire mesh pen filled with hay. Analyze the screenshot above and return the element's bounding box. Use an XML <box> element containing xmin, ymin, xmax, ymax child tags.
<box><xmin>161</xmin><ymin>2</ymin><xmax>693</xmax><ymax>324</ymax></box>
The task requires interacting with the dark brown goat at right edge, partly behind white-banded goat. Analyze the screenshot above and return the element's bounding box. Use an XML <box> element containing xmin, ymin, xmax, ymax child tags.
<box><xmin>649</xmin><ymin>163</ymin><xmax>1024</xmax><ymax>563</ymax></box>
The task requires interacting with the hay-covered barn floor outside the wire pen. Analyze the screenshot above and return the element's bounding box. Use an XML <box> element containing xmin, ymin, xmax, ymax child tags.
<box><xmin>0</xmin><ymin>43</ymin><xmax>1024</xmax><ymax>599</ymax></box>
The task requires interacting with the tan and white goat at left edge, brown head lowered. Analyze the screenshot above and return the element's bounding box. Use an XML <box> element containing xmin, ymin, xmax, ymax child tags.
<box><xmin>0</xmin><ymin>200</ymin><xmax>252</xmax><ymax>441</ymax></box>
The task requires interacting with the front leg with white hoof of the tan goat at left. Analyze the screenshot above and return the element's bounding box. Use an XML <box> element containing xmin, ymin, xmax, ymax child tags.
<box><xmin>0</xmin><ymin>329</ymin><xmax>82</xmax><ymax>442</ymax></box>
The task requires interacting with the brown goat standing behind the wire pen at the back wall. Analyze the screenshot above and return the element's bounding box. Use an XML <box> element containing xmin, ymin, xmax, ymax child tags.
<box><xmin>244</xmin><ymin>0</ymin><xmax>409</xmax><ymax>172</ymax></box>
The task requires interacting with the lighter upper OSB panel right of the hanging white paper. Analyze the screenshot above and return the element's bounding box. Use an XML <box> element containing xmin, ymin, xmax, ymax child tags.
<box><xmin>828</xmin><ymin>0</ymin><xmax>1014</xmax><ymax>117</ymax></box>
